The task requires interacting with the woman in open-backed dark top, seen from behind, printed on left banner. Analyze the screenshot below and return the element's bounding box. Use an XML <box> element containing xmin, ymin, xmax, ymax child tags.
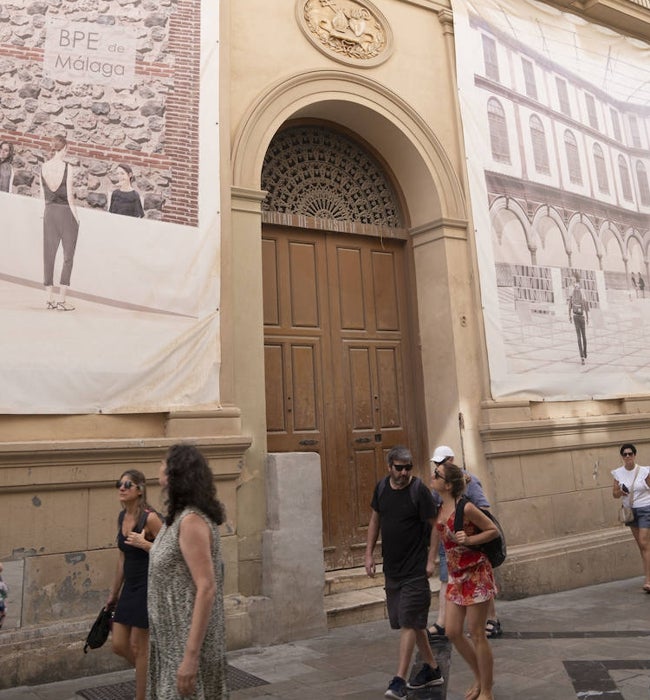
<box><xmin>41</xmin><ymin>135</ymin><xmax>79</xmax><ymax>311</ymax></box>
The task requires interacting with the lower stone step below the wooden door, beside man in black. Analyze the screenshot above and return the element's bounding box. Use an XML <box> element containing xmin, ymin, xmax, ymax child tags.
<box><xmin>324</xmin><ymin>578</ymin><xmax>440</xmax><ymax>629</ymax></box>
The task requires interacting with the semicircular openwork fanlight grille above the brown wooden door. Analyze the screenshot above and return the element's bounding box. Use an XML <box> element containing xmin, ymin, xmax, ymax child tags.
<box><xmin>262</xmin><ymin>126</ymin><xmax>403</xmax><ymax>228</ymax></box>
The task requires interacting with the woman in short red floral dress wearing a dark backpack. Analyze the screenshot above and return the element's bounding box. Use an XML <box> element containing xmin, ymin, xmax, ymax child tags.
<box><xmin>431</xmin><ymin>464</ymin><xmax>499</xmax><ymax>700</ymax></box>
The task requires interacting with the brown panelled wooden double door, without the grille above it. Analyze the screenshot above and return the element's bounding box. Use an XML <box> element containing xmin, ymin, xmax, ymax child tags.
<box><xmin>262</xmin><ymin>226</ymin><xmax>416</xmax><ymax>570</ymax></box>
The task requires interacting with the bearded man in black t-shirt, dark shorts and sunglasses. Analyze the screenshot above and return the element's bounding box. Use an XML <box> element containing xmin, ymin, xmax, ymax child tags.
<box><xmin>365</xmin><ymin>446</ymin><xmax>444</xmax><ymax>698</ymax></box>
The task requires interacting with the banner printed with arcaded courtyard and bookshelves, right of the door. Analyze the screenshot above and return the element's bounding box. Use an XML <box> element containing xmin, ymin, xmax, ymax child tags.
<box><xmin>453</xmin><ymin>0</ymin><xmax>650</xmax><ymax>400</ymax></box>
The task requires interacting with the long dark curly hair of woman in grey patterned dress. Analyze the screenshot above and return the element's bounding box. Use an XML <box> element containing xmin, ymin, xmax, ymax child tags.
<box><xmin>165</xmin><ymin>443</ymin><xmax>226</xmax><ymax>525</ymax></box>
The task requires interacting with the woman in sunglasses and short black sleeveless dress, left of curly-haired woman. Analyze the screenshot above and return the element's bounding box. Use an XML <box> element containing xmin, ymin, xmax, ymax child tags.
<box><xmin>106</xmin><ymin>469</ymin><xmax>162</xmax><ymax>700</ymax></box>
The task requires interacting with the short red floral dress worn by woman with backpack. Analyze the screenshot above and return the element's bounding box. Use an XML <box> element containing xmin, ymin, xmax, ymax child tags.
<box><xmin>436</xmin><ymin>512</ymin><xmax>497</xmax><ymax>606</ymax></box>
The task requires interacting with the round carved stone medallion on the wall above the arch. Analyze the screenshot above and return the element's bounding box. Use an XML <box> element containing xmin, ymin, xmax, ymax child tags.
<box><xmin>296</xmin><ymin>0</ymin><xmax>393</xmax><ymax>67</ymax></box>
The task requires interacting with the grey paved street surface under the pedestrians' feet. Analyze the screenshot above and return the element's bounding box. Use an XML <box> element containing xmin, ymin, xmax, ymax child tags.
<box><xmin>0</xmin><ymin>578</ymin><xmax>650</xmax><ymax>700</ymax></box>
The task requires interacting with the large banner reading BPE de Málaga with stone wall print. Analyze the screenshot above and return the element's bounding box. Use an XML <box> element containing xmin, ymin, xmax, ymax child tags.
<box><xmin>0</xmin><ymin>0</ymin><xmax>220</xmax><ymax>414</ymax></box>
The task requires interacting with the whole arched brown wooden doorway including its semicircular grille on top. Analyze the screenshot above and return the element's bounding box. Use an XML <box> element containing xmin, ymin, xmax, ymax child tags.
<box><xmin>262</xmin><ymin>124</ymin><xmax>421</xmax><ymax>569</ymax></box>
